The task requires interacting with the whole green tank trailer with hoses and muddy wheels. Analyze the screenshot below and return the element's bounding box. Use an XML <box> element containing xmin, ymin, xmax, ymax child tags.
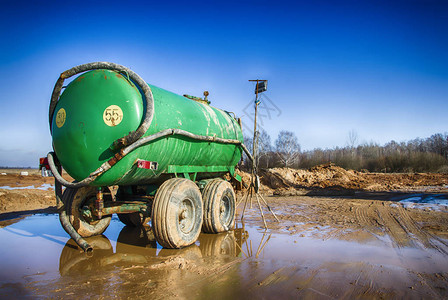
<box><xmin>45</xmin><ymin>62</ymin><xmax>251</xmax><ymax>251</ymax></box>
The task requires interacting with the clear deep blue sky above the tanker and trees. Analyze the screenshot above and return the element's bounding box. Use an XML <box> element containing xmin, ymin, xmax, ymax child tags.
<box><xmin>0</xmin><ymin>1</ymin><xmax>448</xmax><ymax>166</ymax></box>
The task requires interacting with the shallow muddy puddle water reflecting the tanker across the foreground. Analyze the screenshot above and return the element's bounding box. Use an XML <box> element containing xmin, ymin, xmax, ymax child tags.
<box><xmin>4</xmin><ymin>215</ymin><xmax>448</xmax><ymax>299</ymax></box>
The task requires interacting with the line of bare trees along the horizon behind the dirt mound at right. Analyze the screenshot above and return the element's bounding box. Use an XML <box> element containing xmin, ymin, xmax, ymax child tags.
<box><xmin>240</xmin><ymin>128</ymin><xmax>448</xmax><ymax>173</ymax></box>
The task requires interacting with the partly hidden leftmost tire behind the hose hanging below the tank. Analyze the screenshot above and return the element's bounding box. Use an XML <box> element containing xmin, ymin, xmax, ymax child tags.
<box><xmin>62</xmin><ymin>186</ymin><xmax>111</xmax><ymax>238</ymax></box>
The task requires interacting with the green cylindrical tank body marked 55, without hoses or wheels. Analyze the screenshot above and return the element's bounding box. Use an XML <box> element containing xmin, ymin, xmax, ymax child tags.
<box><xmin>51</xmin><ymin>69</ymin><xmax>243</xmax><ymax>186</ymax></box>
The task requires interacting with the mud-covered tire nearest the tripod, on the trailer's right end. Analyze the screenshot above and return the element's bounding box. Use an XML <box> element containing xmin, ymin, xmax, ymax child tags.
<box><xmin>202</xmin><ymin>179</ymin><xmax>236</xmax><ymax>233</ymax></box>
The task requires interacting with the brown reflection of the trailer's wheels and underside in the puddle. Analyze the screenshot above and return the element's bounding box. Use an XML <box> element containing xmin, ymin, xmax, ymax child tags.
<box><xmin>59</xmin><ymin>226</ymin><xmax>248</xmax><ymax>276</ymax></box>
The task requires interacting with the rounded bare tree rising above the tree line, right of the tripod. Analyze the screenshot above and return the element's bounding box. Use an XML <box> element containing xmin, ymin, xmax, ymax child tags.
<box><xmin>275</xmin><ymin>130</ymin><xmax>300</xmax><ymax>167</ymax></box>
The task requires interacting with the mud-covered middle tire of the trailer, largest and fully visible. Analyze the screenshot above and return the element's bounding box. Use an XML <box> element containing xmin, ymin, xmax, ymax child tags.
<box><xmin>151</xmin><ymin>178</ymin><xmax>202</xmax><ymax>248</ymax></box>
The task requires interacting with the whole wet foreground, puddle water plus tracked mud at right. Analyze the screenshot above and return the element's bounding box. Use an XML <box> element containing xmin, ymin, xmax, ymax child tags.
<box><xmin>0</xmin><ymin>197</ymin><xmax>448</xmax><ymax>299</ymax></box>
